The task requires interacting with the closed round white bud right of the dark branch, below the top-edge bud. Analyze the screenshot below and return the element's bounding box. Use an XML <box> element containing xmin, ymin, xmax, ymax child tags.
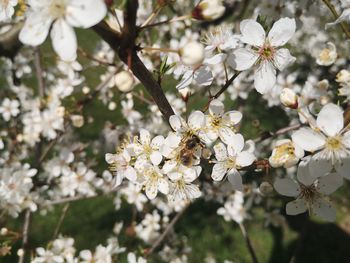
<box><xmin>179</xmin><ymin>41</ymin><xmax>204</xmax><ymax>67</ymax></box>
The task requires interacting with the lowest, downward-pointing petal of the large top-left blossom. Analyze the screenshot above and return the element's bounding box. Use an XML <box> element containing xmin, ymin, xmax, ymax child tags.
<box><xmin>51</xmin><ymin>19</ymin><xmax>78</xmax><ymax>61</ymax></box>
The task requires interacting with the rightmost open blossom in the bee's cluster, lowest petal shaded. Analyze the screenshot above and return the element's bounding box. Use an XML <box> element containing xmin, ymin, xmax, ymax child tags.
<box><xmin>211</xmin><ymin>134</ymin><xmax>255</xmax><ymax>191</ymax></box>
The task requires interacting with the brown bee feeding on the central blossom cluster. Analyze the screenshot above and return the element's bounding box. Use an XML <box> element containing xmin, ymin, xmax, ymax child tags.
<box><xmin>179</xmin><ymin>135</ymin><xmax>203</xmax><ymax>167</ymax></box>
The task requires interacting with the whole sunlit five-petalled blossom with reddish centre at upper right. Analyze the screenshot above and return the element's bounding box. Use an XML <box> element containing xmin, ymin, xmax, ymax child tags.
<box><xmin>227</xmin><ymin>18</ymin><xmax>296</xmax><ymax>94</ymax></box>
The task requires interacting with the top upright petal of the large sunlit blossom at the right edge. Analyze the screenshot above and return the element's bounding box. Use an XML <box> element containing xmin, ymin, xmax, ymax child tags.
<box><xmin>317</xmin><ymin>103</ymin><xmax>344</xmax><ymax>136</ymax></box>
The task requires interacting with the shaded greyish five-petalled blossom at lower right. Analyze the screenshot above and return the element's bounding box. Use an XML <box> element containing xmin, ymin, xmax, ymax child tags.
<box><xmin>274</xmin><ymin>162</ymin><xmax>343</xmax><ymax>221</ymax></box>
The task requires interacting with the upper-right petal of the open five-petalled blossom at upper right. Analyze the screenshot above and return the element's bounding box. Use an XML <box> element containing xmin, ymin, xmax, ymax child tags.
<box><xmin>268</xmin><ymin>17</ymin><xmax>296</xmax><ymax>47</ymax></box>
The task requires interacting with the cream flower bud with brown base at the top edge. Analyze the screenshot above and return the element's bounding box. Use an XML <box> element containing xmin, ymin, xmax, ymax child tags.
<box><xmin>192</xmin><ymin>0</ymin><xmax>225</xmax><ymax>21</ymax></box>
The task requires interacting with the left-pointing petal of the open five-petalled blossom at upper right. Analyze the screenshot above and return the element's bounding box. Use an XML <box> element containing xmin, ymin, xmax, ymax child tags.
<box><xmin>227</xmin><ymin>48</ymin><xmax>259</xmax><ymax>71</ymax></box>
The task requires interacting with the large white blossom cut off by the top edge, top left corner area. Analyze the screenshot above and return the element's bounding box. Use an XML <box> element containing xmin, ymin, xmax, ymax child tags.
<box><xmin>19</xmin><ymin>0</ymin><xmax>107</xmax><ymax>60</ymax></box>
